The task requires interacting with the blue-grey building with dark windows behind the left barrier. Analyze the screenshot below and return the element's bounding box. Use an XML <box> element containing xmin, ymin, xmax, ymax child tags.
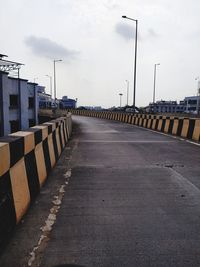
<box><xmin>0</xmin><ymin>54</ymin><xmax>38</xmax><ymax>136</ymax></box>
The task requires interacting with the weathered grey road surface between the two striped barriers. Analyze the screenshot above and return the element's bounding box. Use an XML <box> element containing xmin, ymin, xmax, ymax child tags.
<box><xmin>0</xmin><ymin>117</ymin><xmax>200</xmax><ymax>267</ymax></box>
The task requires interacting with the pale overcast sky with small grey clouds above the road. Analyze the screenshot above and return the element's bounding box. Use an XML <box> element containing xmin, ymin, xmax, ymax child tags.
<box><xmin>0</xmin><ymin>0</ymin><xmax>200</xmax><ymax>107</ymax></box>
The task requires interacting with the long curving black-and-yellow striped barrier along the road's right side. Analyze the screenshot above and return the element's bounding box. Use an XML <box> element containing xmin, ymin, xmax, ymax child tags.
<box><xmin>70</xmin><ymin>110</ymin><xmax>200</xmax><ymax>142</ymax></box>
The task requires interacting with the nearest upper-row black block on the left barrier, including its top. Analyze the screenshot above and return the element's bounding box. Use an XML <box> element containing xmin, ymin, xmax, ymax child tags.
<box><xmin>0</xmin><ymin>136</ymin><xmax>24</xmax><ymax>167</ymax></box>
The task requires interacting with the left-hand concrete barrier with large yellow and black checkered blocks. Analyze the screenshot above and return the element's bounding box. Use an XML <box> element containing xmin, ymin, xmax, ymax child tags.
<box><xmin>0</xmin><ymin>114</ymin><xmax>72</xmax><ymax>246</ymax></box>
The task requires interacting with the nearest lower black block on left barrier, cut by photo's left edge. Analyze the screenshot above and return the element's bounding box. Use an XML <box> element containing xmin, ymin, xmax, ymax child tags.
<box><xmin>0</xmin><ymin>172</ymin><xmax>16</xmax><ymax>247</ymax></box>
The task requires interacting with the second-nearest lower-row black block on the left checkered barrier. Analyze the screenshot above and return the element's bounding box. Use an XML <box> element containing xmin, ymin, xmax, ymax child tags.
<box><xmin>24</xmin><ymin>151</ymin><xmax>40</xmax><ymax>202</ymax></box>
